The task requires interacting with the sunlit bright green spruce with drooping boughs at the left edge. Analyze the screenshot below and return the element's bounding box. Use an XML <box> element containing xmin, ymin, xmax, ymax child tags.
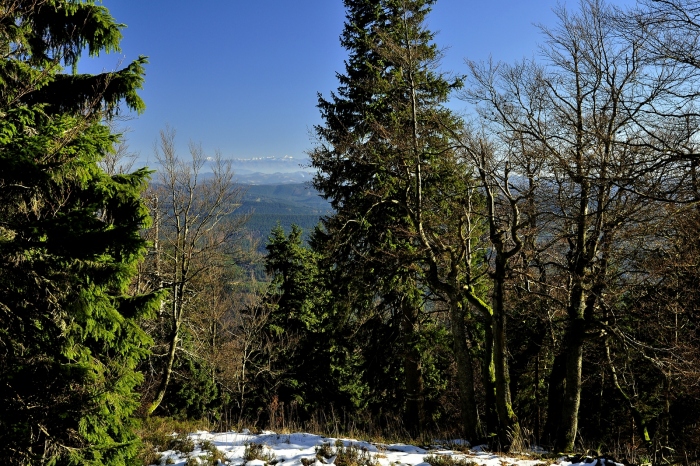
<box><xmin>0</xmin><ymin>0</ymin><xmax>155</xmax><ymax>465</ymax></box>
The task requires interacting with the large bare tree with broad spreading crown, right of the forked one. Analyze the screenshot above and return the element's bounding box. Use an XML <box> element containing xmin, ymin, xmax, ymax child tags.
<box><xmin>470</xmin><ymin>0</ymin><xmax>689</xmax><ymax>450</ymax></box>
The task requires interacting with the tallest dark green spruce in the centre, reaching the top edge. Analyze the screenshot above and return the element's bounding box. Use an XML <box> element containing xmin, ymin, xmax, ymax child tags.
<box><xmin>310</xmin><ymin>0</ymin><xmax>471</xmax><ymax>436</ymax></box>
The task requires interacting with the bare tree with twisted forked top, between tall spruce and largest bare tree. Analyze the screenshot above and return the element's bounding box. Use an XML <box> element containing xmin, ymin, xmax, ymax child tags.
<box><xmin>454</xmin><ymin>125</ymin><xmax>543</xmax><ymax>445</ymax></box>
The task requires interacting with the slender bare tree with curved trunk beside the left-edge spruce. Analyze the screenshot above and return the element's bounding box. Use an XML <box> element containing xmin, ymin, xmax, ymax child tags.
<box><xmin>141</xmin><ymin>127</ymin><xmax>246</xmax><ymax>414</ymax></box>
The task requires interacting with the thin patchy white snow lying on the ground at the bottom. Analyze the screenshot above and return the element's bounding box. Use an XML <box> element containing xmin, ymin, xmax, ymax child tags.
<box><xmin>148</xmin><ymin>429</ymin><xmax>623</xmax><ymax>466</ymax></box>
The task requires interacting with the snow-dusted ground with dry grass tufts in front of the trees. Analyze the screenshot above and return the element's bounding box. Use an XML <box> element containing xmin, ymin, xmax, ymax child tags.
<box><xmin>150</xmin><ymin>429</ymin><xmax>623</xmax><ymax>466</ymax></box>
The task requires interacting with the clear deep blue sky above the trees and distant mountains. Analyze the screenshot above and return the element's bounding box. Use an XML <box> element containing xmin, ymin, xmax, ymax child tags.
<box><xmin>79</xmin><ymin>0</ymin><xmax>632</xmax><ymax>171</ymax></box>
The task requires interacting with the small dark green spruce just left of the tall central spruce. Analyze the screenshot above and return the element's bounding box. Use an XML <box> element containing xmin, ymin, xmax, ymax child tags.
<box><xmin>265</xmin><ymin>225</ymin><xmax>363</xmax><ymax>419</ymax></box>
